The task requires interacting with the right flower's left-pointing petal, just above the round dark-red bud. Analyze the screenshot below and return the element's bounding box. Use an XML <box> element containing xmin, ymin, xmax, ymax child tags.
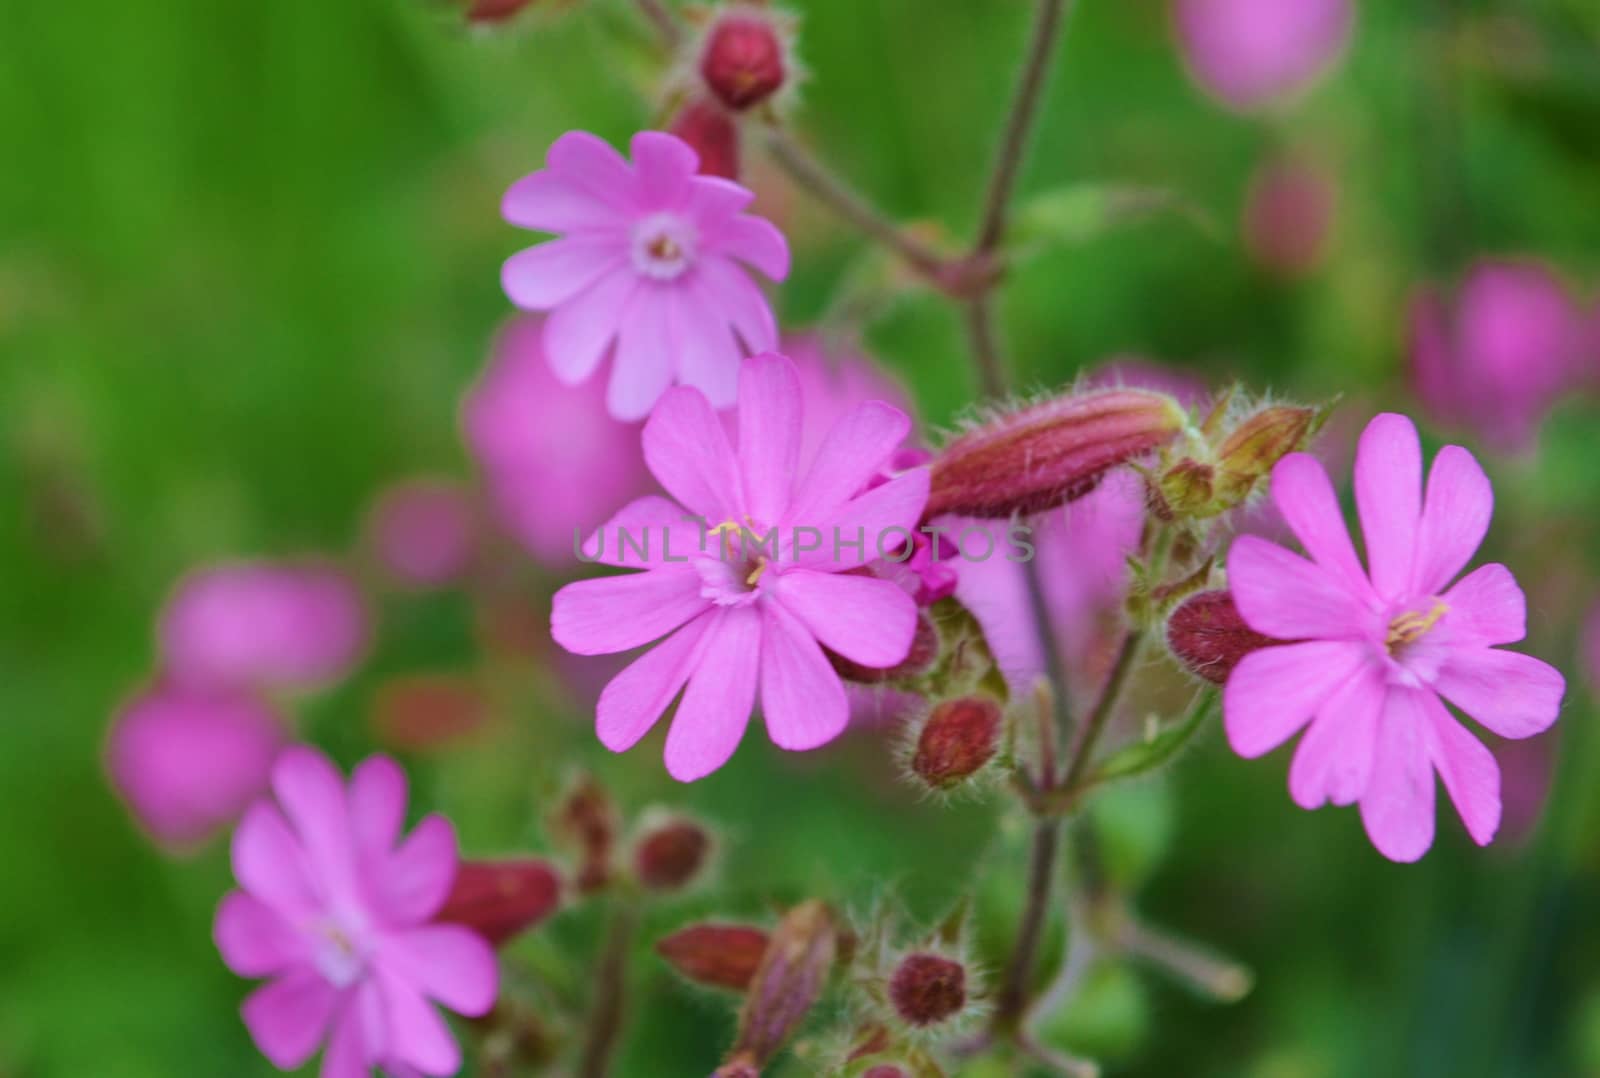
<box><xmin>1227</xmin><ymin>536</ymin><xmax>1371</xmax><ymax>640</ymax></box>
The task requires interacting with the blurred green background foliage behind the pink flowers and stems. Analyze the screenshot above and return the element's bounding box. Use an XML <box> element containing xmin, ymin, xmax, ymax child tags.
<box><xmin>0</xmin><ymin>0</ymin><xmax>1600</xmax><ymax>1078</ymax></box>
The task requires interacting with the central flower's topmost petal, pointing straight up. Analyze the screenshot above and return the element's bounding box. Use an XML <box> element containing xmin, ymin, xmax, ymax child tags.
<box><xmin>739</xmin><ymin>352</ymin><xmax>800</xmax><ymax>521</ymax></box>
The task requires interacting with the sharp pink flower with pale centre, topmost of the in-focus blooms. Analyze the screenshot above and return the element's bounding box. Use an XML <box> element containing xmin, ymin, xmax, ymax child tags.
<box><xmin>501</xmin><ymin>131</ymin><xmax>789</xmax><ymax>419</ymax></box>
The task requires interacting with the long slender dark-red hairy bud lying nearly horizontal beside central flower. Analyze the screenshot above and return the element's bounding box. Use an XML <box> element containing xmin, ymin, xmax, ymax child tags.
<box><xmin>923</xmin><ymin>389</ymin><xmax>1187</xmax><ymax>520</ymax></box>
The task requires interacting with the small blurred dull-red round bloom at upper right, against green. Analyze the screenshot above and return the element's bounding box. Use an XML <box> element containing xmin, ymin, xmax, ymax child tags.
<box><xmin>1240</xmin><ymin>155</ymin><xmax>1339</xmax><ymax>277</ymax></box>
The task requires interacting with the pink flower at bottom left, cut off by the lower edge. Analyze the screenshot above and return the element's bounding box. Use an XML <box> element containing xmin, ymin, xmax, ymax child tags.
<box><xmin>214</xmin><ymin>747</ymin><xmax>498</xmax><ymax>1078</ymax></box>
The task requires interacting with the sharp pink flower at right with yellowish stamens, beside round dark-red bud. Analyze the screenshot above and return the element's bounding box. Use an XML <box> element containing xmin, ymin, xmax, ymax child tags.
<box><xmin>1222</xmin><ymin>414</ymin><xmax>1565</xmax><ymax>860</ymax></box>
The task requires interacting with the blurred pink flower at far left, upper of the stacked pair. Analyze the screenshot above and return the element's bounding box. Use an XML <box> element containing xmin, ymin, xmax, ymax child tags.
<box><xmin>158</xmin><ymin>561</ymin><xmax>368</xmax><ymax>688</ymax></box>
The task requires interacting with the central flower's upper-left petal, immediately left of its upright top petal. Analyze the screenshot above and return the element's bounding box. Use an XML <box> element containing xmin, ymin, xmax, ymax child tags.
<box><xmin>642</xmin><ymin>385</ymin><xmax>744</xmax><ymax>526</ymax></box>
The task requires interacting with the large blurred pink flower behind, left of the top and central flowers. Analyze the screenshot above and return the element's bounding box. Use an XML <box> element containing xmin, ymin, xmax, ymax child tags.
<box><xmin>462</xmin><ymin>315</ymin><xmax>646</xmax><ymax>568</ymax></box>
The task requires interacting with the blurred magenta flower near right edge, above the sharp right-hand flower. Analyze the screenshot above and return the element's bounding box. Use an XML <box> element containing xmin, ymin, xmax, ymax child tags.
<box><xmin>1411</xmin><ymin>261</ymin><xmax>1586</xmax><ymax>453</ymax></box>
